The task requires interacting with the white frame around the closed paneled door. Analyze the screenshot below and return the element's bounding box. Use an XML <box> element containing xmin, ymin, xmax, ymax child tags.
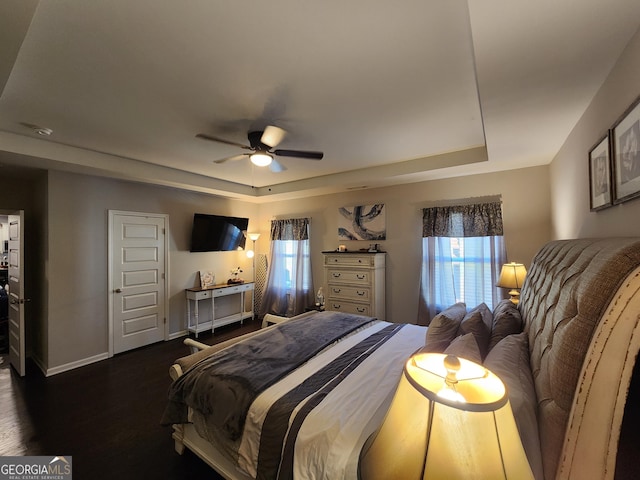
<box><xmin>107</xmin><ymin>210</ymin><xmax>170</xmax><ymax>358</ymax></box>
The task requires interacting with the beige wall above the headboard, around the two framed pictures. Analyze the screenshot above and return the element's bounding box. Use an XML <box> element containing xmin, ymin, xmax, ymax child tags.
<box><xmin>551</xmin><ymin>26</ymin><xmax>640</xmax><ymax>238</ymax></box>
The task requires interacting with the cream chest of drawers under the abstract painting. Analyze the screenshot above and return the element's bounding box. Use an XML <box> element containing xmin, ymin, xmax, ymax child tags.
<box><xmin>322</xmin><ymin>252</ymin><xmax>386</xmax><ymax>320</ymax></box>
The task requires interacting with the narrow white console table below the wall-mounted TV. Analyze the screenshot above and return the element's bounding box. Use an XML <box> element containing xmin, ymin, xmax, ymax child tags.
<box><xmin>185</xmin><ymin>282</ymin><xmax>254</xmax><ymax>338</ymax></box>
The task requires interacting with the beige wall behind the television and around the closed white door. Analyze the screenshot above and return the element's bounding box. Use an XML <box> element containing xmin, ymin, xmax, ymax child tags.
<box><xmin>42</xmin><ymin>171</ymin><xmax>258</xmax><ymax>369</ymax></box>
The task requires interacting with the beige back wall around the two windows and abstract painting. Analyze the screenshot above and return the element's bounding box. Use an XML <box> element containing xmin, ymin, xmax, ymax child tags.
<box><xmin>258</xmin><ymin>166</ymin><xmax>551</xmax><ymax>323</ymax></box>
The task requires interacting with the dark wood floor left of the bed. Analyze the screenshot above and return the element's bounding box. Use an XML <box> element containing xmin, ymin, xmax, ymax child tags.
<box><xmin>0</xmin><ymin>320</ymin><xmax>260</xmax><ymax>480</ymax></box>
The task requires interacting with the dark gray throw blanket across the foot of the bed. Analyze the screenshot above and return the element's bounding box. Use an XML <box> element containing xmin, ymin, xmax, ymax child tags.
<box><xmin>161</xmin><ymin>312</ymin><xmax>375</xmax><ymax>440</ymax></box>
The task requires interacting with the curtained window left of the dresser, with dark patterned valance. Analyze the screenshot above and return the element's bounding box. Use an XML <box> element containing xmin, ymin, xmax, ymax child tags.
<box><xmin>262</xmin><ymin>218</ymin><xmax>314</xmax><ymax>316</ymax></box>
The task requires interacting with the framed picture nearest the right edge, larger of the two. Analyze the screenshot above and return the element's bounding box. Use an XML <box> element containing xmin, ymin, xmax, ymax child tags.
<box><xmin>611</xmin><ymin>97</ymin><xmax>640</xmax><ymax>203</ymax></box>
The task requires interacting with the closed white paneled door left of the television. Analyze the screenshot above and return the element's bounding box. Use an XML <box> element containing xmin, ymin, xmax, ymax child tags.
<box><xmin>109</xmin><ymin>212</ymin><xmax>168</xmax><ymax>355</ymax></box>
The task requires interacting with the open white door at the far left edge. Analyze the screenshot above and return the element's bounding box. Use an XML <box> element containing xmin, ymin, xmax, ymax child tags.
<box><xmin>7</xmin><ymin>210</ymin><xmax>29</xmax><ymax>377</ymax></box>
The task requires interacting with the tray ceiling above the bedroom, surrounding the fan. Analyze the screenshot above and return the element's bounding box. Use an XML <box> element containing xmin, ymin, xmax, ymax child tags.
<box><xmin>0</xmin><ymin>0</ymin><xmax>640</xmax><ymax>200</ymax></box>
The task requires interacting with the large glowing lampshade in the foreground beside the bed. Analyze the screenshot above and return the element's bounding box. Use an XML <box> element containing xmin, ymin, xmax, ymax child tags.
<box><xmin>359</xmin><ymin>353</ymin><xmax>533</xmax><ymax>480</ymax></box>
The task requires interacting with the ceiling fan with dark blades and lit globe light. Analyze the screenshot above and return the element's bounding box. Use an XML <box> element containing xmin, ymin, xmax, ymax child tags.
<box><xmin>196</xmin><ymin>125</ymin><xmax>324</xmax><ymax>173</ymax></box>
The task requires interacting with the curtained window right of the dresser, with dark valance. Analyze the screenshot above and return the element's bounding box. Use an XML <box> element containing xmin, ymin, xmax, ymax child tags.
<box><xmin>418</xmin><ymin>202</ymin><xmax>507</xmax><ymax>325</ymax></box>
